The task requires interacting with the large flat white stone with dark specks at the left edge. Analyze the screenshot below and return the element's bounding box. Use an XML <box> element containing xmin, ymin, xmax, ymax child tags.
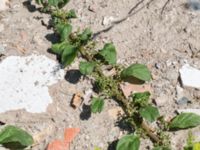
<box><xmin>0</xmin><ymin>54</ymin><xmax>64</xmax><ymax>113</ymax></box>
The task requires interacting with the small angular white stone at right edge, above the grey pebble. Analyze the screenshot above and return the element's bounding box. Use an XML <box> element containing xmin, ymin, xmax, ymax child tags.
<box><xmin>180</xmin><ymin>64</ymin><xmax>200</xmax><ymax>88</ymax></box>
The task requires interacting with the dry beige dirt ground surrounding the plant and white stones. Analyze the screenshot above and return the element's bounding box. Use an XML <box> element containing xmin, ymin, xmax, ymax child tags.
<box><xmin>0</xmin><ymin>0</ymin><xmax>200</xmax><ymax>150</ymax></box>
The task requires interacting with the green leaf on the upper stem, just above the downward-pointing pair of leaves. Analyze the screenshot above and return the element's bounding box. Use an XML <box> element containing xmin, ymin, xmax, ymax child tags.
<box><xmin>56</xmin><ymin>24</ymin><xmax>72</xmax><ymax>41</ymax></box>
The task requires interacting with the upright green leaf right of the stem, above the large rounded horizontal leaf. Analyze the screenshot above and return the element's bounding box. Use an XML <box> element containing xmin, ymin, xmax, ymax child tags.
<box><xmin>99</xmin><ymin>43</ymin><xmax>117</xmax><ymax>65</ymax></box>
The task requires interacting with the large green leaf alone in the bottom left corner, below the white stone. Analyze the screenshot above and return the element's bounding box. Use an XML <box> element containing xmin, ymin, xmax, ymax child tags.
<box><xmin>0</xmin><ymin>125</ymin><xmax>33</xmax><ymax>149</ymax></box>
